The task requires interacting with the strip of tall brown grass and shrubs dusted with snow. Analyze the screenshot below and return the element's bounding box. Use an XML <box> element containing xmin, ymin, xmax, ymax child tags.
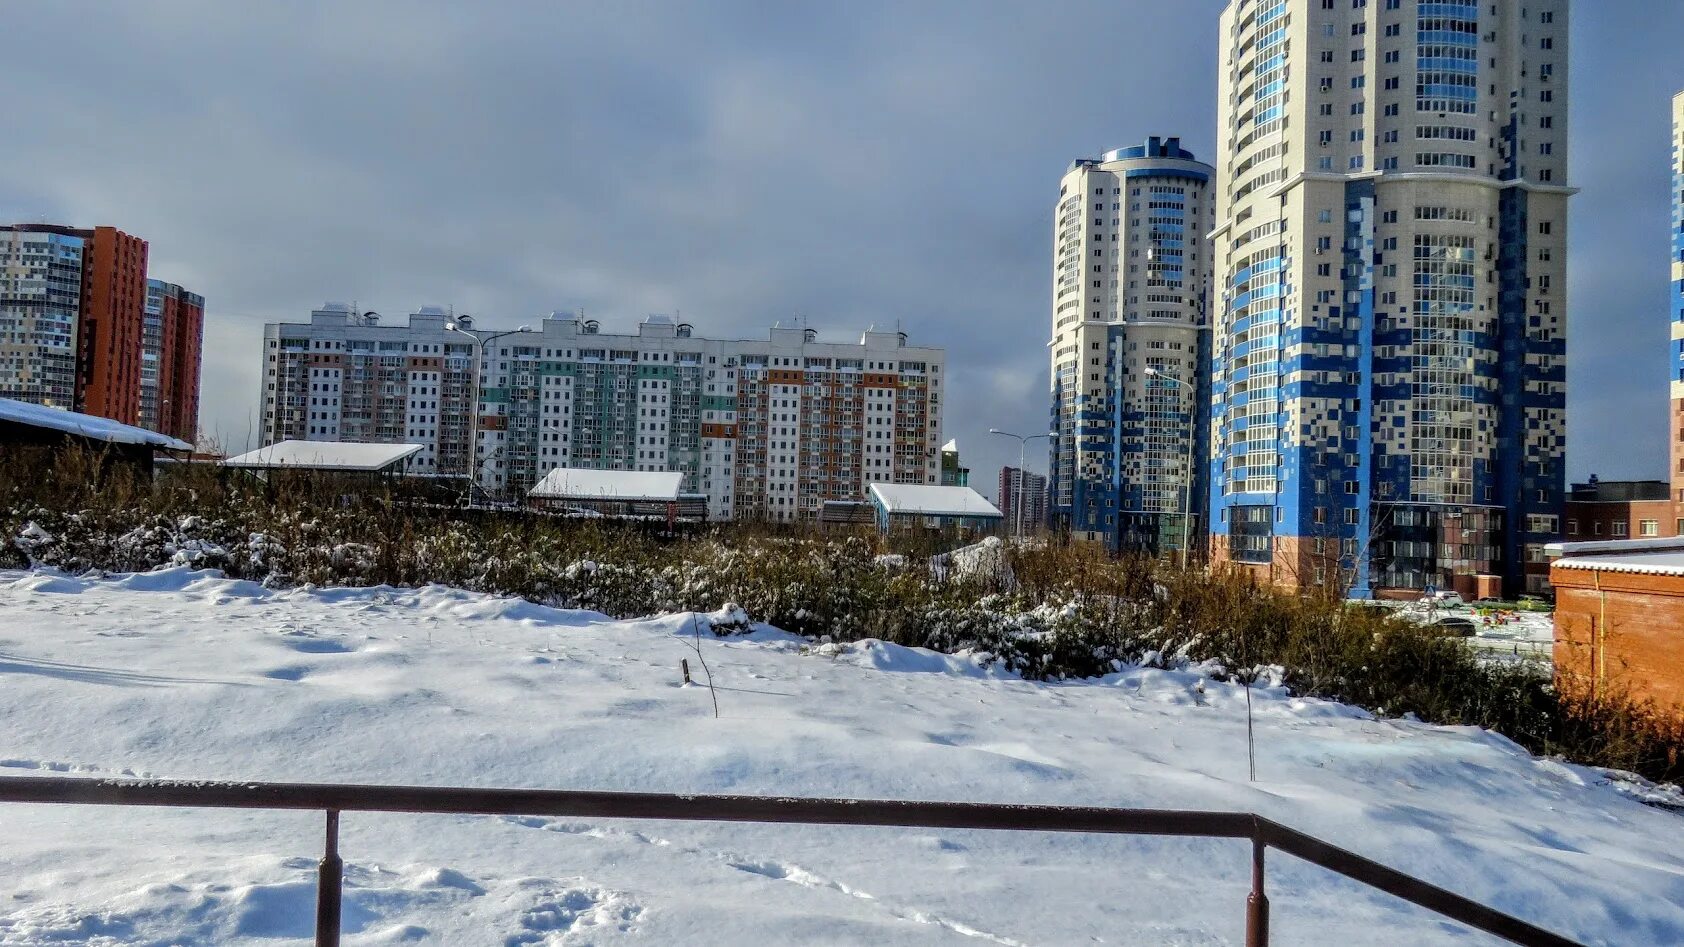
<box><xmin>0</xmin><ymin>448</ymin><xmax>1684</xmax><ymax>780</ymax></box>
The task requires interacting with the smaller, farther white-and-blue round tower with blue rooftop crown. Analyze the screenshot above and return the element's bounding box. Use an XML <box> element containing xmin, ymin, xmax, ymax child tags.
<box><xmin>1049</xmin><ymin>138</ymin><xmax>1214</xmax><ymax>553</ymax></box>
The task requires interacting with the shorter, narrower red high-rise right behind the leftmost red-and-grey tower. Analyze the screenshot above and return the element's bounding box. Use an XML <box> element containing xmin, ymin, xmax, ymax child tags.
<box><xmin>138</xmin><ymin>280</ymin><xmax>205</xmax><ymax>443</ymax></box>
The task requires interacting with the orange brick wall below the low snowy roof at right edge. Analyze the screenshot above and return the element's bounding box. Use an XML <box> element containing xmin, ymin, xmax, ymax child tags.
<box><xmin>1549</xmin><ymin>568</ymin><xmax>1684</xmax><ymax>713</ymax></box>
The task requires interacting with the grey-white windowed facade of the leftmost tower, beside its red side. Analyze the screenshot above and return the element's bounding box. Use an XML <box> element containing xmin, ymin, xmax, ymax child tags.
<box><xmin>0</xmin><ymin>227</ymin><xmax>86</xmax><ymax>411</ymax></box>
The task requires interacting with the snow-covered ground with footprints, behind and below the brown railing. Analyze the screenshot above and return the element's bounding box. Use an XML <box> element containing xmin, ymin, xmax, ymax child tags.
<box><xmin>0</xmin><ymin>570</ymin><xmax>1684</xmax><ymax>945</ymax></box>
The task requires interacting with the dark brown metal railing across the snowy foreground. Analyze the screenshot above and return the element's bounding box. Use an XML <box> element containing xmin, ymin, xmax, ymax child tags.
<box><xmin>0</xmin><ymin>777</ymin><xmax>1575</xmax><ymax>947</ymax></box>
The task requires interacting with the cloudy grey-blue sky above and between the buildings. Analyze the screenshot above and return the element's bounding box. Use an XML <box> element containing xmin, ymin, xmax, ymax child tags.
<box><xmin>0</xmin><ymin>0</ymin><xmax>1684</xmax><ymax>494</ymax></box>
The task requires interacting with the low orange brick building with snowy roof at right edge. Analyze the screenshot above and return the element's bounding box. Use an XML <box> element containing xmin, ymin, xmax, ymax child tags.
<box><xmin>1549</xmin><ymin>538</ymin><xmax>1684</xmax><ymax>713</ymax></box>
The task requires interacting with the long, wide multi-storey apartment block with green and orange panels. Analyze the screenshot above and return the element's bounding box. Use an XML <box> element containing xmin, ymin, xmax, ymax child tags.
<box><xmin>263</xmin><ymin>305</ymin><xmax>945</xmax><ymax>521</ymax></box>
